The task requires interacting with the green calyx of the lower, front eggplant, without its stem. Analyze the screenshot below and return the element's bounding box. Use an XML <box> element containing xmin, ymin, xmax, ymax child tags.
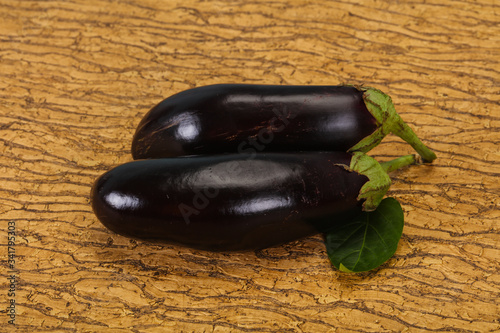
<box><xmin>349</xmin><ymin>152</ymin><xmax>391</xmax><ymax>212</ymax></box>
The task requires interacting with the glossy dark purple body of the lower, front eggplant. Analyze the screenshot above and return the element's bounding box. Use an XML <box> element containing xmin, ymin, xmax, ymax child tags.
<box><xmin>91</xmin><ymin>152</ymin><xmax>368</xmax><ymax>251</ymax></box>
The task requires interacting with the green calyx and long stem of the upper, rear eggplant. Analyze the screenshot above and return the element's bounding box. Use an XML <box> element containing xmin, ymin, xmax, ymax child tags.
<box><xmin>349</xmin><ymin>87</ymin><xmax>436</xmax><ymax>162</ymax></box>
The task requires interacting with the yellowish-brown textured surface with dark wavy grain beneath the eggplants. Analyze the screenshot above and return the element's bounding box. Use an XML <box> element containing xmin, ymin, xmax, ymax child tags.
<box><xmin>0</xmin><ymin>0</ymin><xmax>500</xmax><ymax>332</ymax></box>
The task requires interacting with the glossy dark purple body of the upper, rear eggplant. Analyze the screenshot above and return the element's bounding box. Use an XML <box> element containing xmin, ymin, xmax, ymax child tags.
<box><xmin>132</xmin><ymin>84</ymin><xmax>377</xmax><ymax>159</ymax></box>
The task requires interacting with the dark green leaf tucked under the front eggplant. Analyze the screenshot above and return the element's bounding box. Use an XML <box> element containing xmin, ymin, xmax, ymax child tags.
<box><xmin>326</xmin><ymin>198</ymin><xmax>404</xmax><ymax>273</ymax></box>
